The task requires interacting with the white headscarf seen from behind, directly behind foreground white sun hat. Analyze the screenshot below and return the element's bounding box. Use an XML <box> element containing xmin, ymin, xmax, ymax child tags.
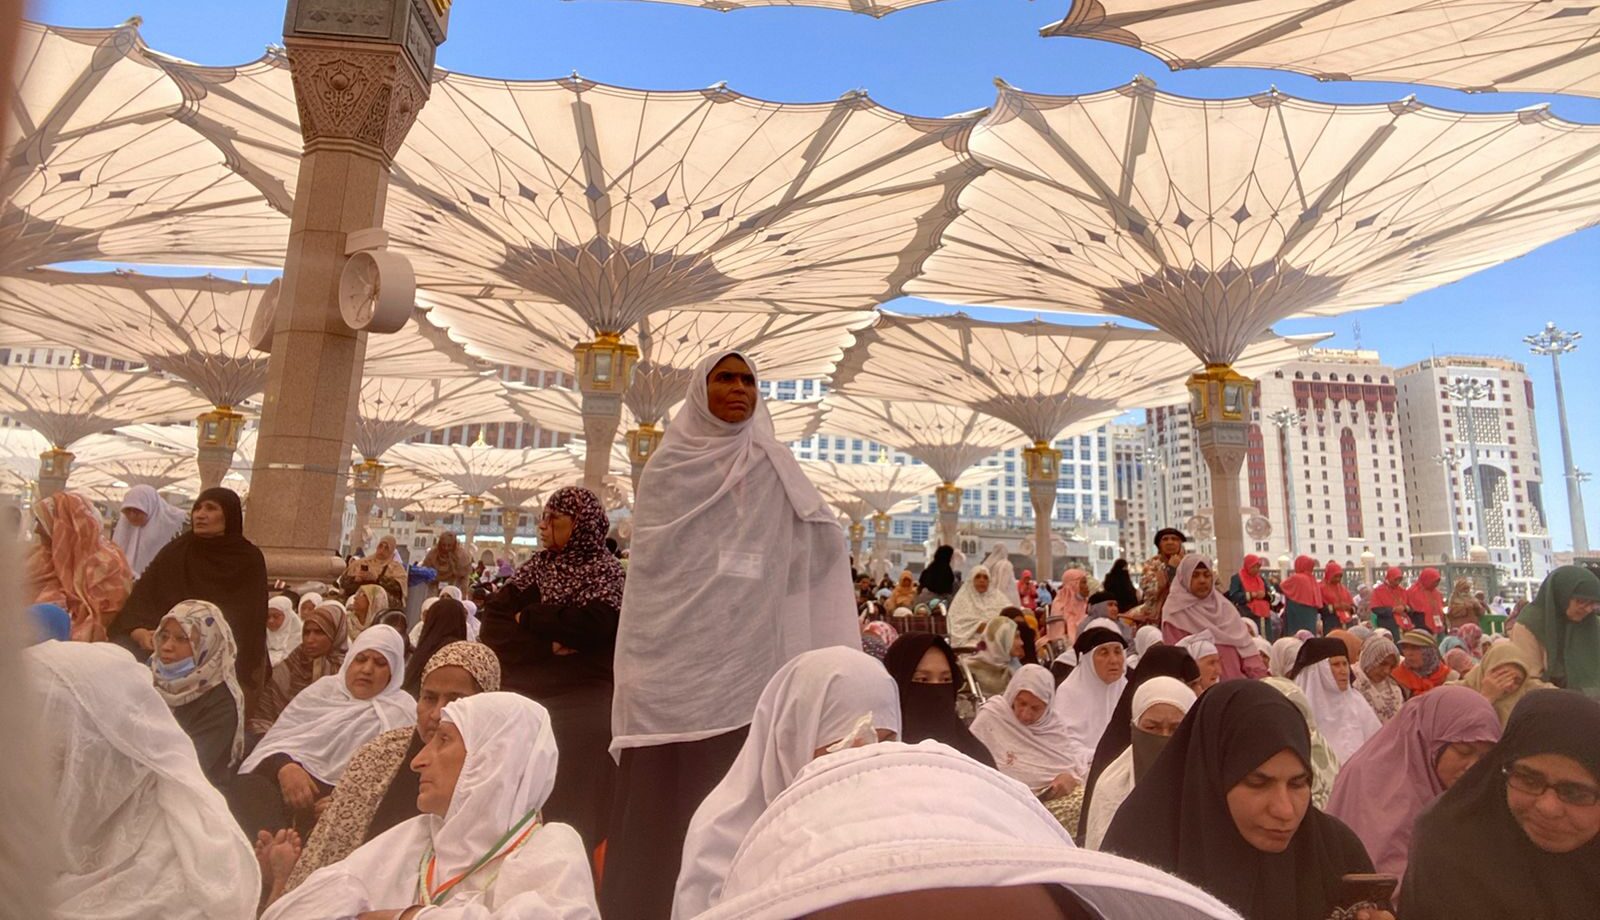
<box><xmin>672</xmin><ymin>648</ymin><xmax>901</xmax><ymax>920</ymax></box>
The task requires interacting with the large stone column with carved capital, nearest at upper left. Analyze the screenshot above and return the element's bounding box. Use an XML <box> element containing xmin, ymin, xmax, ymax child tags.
<box><xmin>245</xmin><ymin>0</ymin><xmax>450</xmax><ymax>578</ymax></box>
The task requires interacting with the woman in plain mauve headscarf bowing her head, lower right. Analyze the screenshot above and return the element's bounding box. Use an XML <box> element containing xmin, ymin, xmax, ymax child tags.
<box><xmin>1328</xmin><ymin>686</ymin><xmax>1501</xmax><ymax>877</ymax></box>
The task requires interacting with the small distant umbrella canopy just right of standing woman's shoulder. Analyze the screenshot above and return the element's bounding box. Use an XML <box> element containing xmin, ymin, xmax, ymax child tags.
<box><xmin>819</xmin><ymin>394</ymin><xmax>1027</xmax><ymax>482</ymax></box>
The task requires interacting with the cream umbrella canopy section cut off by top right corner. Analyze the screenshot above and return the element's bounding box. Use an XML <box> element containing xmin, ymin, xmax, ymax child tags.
<box><xmin>1043</xmin><ymin>0</ymin><xmax>1600</xmax><ymax>96</ymax></box>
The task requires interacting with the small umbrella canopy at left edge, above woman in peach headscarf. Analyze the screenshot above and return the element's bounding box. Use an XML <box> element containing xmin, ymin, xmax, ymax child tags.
<box><xmin>0</xmin><ymin>365</ymin><xmax>211</xmax><ymax>448</ymax></box>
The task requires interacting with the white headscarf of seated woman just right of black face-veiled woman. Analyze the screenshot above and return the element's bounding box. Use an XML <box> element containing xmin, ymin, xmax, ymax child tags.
<box><xmin>971</xmin><ymin>664</ymin><xmax>1072</xmax><ymax>792</ymax></box>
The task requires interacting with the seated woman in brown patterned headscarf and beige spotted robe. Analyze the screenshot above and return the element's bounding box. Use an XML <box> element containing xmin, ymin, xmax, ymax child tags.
<box><xmin>272</xmin><ymin>642</ymin><xmax>501</xmax><ymax>893</ymax></box>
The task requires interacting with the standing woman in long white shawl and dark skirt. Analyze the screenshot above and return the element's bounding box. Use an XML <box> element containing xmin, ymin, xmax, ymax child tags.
<box><xmin>602</xmin><ymin>352</ymin><xmax>861</xmax><ymax>920</ymax></box>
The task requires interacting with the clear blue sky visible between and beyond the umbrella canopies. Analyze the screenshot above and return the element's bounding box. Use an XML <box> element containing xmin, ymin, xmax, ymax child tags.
<box><xmin>29</xmin><ymin>0</ymin><xmax>1600</xmax><ymax>549</ymax></box>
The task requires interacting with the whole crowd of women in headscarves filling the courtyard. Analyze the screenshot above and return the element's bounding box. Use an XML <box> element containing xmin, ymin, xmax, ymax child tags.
<box><xmin>22</xmin><ymin>352</ymin><xmax>1600</xmax><ymax>920</ymax></box>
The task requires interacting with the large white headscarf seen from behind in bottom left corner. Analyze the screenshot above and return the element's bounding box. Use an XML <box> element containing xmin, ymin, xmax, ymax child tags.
<box><xmin>22</xmin><ymin>642</ymin><xmax>261</xmax><ymax>920</ymax></box>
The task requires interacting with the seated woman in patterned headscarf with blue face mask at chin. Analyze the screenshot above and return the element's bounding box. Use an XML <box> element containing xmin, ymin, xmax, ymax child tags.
<box><xmin>150</xmin><ymin>600</ymin><xmax>245</xmax><ymax>789</ymax></box>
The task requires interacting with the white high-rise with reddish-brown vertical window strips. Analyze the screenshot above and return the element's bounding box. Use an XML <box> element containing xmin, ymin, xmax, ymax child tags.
<box><xmin>1242</xmin><ymin>349</ymin><xmax>1411</xmax><ymax>568</ymax></box>
